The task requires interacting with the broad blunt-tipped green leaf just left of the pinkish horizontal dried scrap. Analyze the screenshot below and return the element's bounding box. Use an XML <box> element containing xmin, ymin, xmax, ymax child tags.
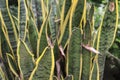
<box><xmin>66</xmin><ymin>28</ymin><xmax>82</xmax><ymax>80</ymax></box>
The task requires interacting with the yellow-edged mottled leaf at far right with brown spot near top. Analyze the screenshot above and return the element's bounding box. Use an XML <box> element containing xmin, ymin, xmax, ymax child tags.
<box><xmin>99</xmin><ymin>0</ymin><xmax>118</xmax><ymax>52</ymax></box>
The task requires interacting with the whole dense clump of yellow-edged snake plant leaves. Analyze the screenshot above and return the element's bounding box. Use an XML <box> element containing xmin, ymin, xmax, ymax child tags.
<box><xmin>0</xmin><ymin>0</ymin><xmax>118</xmax><ymax>80</ymax></box>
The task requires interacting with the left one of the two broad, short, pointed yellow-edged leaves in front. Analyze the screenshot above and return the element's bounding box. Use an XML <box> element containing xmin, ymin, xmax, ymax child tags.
<box><xmin>17</xmin><ymin>41</ymin><xmax>34</xmax><ymax>80</ymax></box>
